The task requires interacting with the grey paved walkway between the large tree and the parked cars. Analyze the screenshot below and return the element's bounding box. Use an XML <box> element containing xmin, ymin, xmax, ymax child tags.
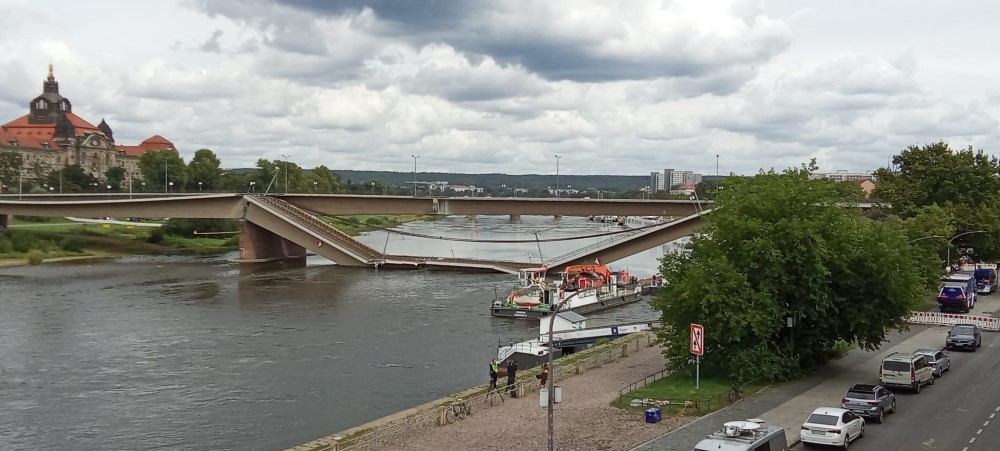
<box><xmin>633</xmin><ymin>324</ymin><xmax>928</xmax><ymax>451</ymax></box>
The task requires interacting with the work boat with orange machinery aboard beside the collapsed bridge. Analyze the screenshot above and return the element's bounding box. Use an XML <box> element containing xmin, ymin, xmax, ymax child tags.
<box><xmin>490</xmin><ymin>263</ymin><xmax>644</xmax><ymax>318</ymax></box>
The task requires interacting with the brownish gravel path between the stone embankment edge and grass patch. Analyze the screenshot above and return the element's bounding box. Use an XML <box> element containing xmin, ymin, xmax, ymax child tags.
<box><xmin>379</xmin><ymin>347</ymin><xmax>695</xmax><ymax>451</ymax></box>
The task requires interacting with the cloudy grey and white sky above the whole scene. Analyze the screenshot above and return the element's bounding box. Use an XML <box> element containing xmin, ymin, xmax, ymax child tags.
<box><xmin>0</xmin><ymin>0</ymin><xmax>1000</xmax><ymax>175</ymax></box>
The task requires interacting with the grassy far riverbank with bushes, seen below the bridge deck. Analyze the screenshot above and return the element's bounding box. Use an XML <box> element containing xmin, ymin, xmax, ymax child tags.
<box><xmin>0</xmin><ymin>215</ymin><xmax>436</xmax><ymax>267</ymax></box>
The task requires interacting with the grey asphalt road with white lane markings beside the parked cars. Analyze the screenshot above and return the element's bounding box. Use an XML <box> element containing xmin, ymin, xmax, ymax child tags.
<box><xmin>792</xmin><ymin>333</ymin><xmax>1000</xmax><ymax>451</ymax></box>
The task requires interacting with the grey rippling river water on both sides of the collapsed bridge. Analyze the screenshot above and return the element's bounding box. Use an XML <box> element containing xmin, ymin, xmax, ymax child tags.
<box><xmin>0</xmin><ymin>216</ymin><xmax>676</xmax><ymax>450</ymax></box>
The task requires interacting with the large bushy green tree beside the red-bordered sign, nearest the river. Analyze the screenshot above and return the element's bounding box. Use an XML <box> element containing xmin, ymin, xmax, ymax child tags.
<box><xmin>654</xmin><ymin>165</ymin><xmax>929</xmax><ymax>380</ymax></box>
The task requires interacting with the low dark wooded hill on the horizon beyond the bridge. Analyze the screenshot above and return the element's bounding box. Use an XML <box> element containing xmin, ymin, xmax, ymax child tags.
<box><xmin>333</xmin><ymin>170</ymin><xmax>649</xmax><ymax>192</ymax></box>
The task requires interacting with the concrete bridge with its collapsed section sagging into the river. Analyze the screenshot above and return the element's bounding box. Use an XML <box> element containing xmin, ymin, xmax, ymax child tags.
<box><xmin>0</xmin><ymin>193</ymin><xmax>711</xmax><ymax>273</ymax></box>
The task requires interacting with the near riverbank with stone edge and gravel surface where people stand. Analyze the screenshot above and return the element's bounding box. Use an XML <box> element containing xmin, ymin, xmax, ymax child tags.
<box><xmin>291</xmin><ymin>333</ymin><xmax>695</xmax><ymax>451</ymax></box>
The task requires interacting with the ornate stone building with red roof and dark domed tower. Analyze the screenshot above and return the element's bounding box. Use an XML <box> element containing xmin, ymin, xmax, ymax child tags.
<box><xmin>0</xmin><ymin>64</ymin><xmax>174</xmax><ymax>189</ymax></box>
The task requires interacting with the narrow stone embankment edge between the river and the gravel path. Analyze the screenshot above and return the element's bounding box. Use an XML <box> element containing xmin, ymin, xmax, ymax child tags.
<box><xmin>289</xmin><ymin>332</ymin><xmax>656</xmax><ymax>451</ymax></box>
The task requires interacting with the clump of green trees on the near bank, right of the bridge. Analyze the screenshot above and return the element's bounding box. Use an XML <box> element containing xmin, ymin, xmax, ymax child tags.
<box><xmin>654</xmin><ymin>142</ymin><xmax>1000</xmax><ymax>381</ymax></box>
